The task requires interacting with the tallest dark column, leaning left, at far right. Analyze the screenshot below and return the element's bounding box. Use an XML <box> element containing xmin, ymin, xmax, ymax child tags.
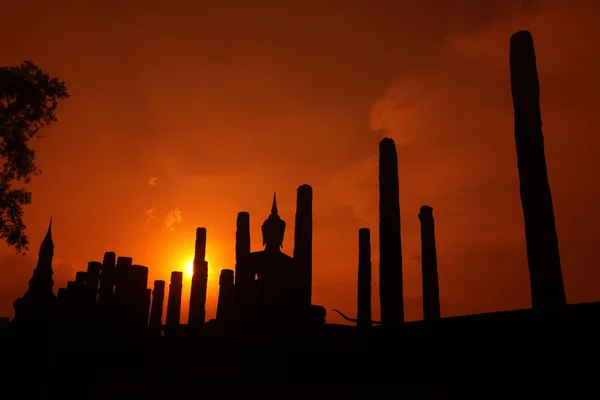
<box><xmin>510</xmin><ymin>31</ymin><xmax>567</xmax><ymax>310</ymax></box>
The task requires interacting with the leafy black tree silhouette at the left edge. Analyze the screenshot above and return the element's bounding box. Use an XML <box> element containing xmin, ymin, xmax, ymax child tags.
<box><xmin>0</xmin><ymin>61</ymin><xmax>69</xmax><ymax>254</ymax></box>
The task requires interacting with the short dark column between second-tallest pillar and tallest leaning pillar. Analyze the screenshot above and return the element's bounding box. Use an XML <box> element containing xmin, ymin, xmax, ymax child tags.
<box><xmin>419</xmin><ymin>206</ymin><xmax>441</xmax><ymax>321</ymax></box>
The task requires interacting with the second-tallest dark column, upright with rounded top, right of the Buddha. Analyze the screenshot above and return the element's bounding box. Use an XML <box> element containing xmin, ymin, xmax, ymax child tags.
<box><xmin>379</xmin><ymin>138</ymin><xmax>404</xmax><ymax>326</ymax></box>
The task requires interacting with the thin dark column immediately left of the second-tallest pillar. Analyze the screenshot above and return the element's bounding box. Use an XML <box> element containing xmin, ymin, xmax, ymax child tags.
<box><xmin>356</xmin><ymin>228</ymin><xmax>372</xmax><ymax>328</ymax></box>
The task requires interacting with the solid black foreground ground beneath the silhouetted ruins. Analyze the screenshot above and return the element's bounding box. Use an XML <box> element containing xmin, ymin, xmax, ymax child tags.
<box><xmin>0</xmin><ymin>303</ymin><xmax>600</xmax><ymax>399</ymax></box>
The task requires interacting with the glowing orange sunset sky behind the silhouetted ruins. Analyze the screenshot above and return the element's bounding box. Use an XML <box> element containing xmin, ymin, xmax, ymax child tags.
<box><xmin>0</xmin><ymin>0</ymin><xmax>600</xmax><ymax>322</ymax></box>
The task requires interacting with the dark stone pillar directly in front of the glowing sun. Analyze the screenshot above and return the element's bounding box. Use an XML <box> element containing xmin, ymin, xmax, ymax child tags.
<box><xmin>188</xmin><ymin>228</ymin><xmax>208</xmax><ymax>327</ymax></box>
